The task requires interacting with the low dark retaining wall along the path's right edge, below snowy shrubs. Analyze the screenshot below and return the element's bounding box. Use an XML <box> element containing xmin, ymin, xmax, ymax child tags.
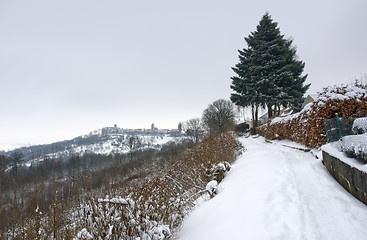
<box><xmin>322</xmin><ymin>151</ymin><xmax>367</xmax><ymax>205</ymax></box>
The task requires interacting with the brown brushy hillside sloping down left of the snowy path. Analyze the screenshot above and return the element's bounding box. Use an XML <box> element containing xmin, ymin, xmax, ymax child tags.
<box><xmin>0</xmin><ymin>132</ymin><xmax>241</xmax><ymax>239</ymax></box>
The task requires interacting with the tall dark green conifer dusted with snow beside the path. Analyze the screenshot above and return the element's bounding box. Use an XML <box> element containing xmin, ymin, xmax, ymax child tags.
<box><xmin>231</xmin><ymin>13</ymin><xmax>310</xmax><ymax>122</ymax></box>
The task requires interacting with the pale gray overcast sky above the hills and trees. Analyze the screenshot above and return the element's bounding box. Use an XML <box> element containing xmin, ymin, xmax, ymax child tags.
<box><xmin>0</xmin><ymin>0</ymin><xmax>367</xmax><ymax>147</ymax></box>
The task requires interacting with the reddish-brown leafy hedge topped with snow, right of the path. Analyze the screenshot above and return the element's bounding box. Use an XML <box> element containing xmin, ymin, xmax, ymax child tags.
<box><xmin>257</xmin><ymin>83</ymin><xmax>367</xmax><ymax>148</ymax></box>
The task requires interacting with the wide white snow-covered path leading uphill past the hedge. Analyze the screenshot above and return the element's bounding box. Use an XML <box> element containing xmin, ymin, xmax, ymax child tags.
<box><xmin>179</xmin><ymin>137</ymin><xmax>367</xmax><ymax>240</ymax></box>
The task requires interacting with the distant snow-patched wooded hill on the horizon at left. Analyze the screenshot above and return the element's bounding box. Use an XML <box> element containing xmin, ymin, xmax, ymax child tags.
<box><xmin>0</xmin><ymin>126</ymin><xmax>186</xmax><ymax>164</ymax></box>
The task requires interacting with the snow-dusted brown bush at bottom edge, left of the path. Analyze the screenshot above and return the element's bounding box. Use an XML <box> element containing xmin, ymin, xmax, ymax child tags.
<box><xmin>76</xmin><ymin>196</ymin><xmax>171</xmax><ymax>240</ymax></box>
